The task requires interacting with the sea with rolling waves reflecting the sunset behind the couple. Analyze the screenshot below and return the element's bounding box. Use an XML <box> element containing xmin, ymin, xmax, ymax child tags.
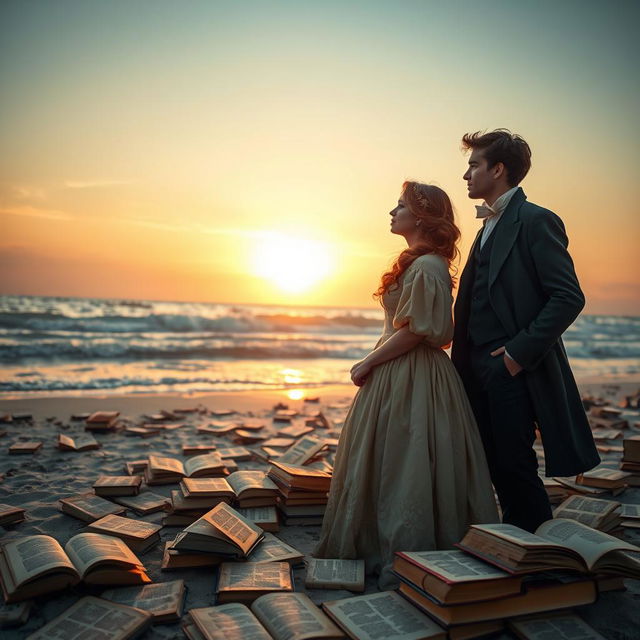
<box><xmin>0</xmin><ymin>296</ymin><xmax>640</xmax><ymax>399</ymax></box>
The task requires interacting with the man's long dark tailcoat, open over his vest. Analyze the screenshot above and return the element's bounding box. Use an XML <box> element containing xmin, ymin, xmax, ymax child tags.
<box><xmin>451</xmin><ymin>189</ymin><xmax>600</xmax><ymax>476</ymax></box>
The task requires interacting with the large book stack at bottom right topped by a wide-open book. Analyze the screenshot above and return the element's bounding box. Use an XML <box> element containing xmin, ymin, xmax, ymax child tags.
<box><xmin>394</xmin><ymin>519</ymin><xmax>640</xmax><ymax>637</ymax></box>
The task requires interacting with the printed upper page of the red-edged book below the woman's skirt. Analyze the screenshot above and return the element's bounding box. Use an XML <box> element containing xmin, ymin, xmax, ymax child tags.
<box><xmin>398</xmin><ymin>549</ymin><xmax>509</xmax><ymax>582</ymax></box>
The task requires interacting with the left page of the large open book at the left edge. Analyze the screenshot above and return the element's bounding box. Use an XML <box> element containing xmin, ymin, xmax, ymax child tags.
<box><xmin>3</xmin><ymin>535</ymin><xmax>77</xmax><ymax>585</ymax></box>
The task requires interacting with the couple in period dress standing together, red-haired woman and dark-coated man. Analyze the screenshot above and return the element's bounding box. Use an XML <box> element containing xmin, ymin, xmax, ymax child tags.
<box><xmin>316</xmin><ymin>129</ymin><xmax>599</xmax><ymax>588</ymax></box>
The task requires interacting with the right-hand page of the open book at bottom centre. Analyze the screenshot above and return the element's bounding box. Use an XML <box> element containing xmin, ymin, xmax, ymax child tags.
<box><xmin>251</xmin><ymin>593</ymin><xmax>344</xmax><ymax>640</ymax></box>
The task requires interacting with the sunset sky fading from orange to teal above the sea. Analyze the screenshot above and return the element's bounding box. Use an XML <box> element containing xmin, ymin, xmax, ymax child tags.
<box><xmin>0</xmin><ymin>0</ymin><xmax>640</xmax><ymax>315</ymax></box>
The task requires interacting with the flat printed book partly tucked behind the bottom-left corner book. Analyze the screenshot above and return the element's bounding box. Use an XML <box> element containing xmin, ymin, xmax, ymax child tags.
<box><xmin>100</xmin><ymin>580</ymin><xmax>186</xmax><ymax>624</ymax></box>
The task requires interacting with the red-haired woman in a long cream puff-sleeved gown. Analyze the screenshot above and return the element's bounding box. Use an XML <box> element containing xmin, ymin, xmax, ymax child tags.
<box><xmin>315</xmin><ymin>182</ymin><xmax>498</xmax><ymax>589</ymax></box>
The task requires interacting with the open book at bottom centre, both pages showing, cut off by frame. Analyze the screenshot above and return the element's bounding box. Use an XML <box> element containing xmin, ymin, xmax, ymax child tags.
<box><xmin>183</xmin><ymin>593</ymin><xmax>344</xmax><ymax>640</ymax></box>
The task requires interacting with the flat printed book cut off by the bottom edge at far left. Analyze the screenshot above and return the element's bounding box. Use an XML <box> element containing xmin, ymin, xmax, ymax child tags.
<box><xmin>27</xmin><ymin>596</ymin><xmax>152</xmax><ymax>640</ymax></box>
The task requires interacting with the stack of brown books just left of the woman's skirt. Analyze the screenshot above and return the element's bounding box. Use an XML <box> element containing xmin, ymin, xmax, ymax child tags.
<box><xmin>268</xmin><ymin>460</ymin><xmax>331</xmax><ymax>525</ymax></box>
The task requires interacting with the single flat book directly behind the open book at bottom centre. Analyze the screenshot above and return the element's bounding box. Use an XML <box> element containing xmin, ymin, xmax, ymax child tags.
<box><xmin>216</xmin><ymin>562</ymin><xmax>293</xmax><ymax>604</ymax></box>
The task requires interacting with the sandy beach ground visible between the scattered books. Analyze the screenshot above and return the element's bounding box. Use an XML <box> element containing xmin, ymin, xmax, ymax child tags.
<box><xmin>0</xmin><ymin>380</ymin><xmax>640</xmax><ymax>640</ymax></box>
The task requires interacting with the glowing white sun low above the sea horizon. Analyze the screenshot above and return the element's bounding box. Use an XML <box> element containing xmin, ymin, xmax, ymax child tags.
<box><xmin>252</xmin><ymin>232</ymin><xmax>332</xmax><ymax>293</ymax></box>
